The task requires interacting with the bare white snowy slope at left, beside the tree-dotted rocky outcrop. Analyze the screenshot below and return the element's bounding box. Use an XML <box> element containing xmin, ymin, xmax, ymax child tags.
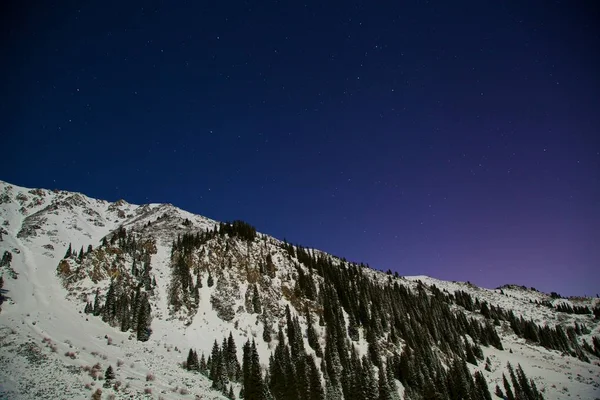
<box><xmin>0</xmin><ymin>182</ymin><xmax>223</xmax><ymax>399</ymax></box>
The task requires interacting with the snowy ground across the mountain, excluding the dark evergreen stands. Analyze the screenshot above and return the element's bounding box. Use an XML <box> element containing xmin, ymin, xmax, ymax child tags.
<box><xmin>0</xmin><ymin>181</ymin><xmax>600</xmax><ymax>399</ymax></box>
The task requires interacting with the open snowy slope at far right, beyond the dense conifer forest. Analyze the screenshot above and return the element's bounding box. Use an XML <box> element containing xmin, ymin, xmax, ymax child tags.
<box><xmin>405</xmin><ymin>276</ymin><xmax>600</xmax><ymax>399</ymax></box>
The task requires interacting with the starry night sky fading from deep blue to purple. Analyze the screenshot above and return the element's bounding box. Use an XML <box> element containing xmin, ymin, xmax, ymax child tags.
<box><xmin>0</xmin><ymin>1</ymin><xmax>600</xmax><ymax>295</ymax></box>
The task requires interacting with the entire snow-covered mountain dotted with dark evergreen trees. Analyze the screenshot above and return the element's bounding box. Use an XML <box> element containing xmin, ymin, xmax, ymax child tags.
<box><xmin>0</xmin><ymin>181</ymin><xmax>600</xmax><ymax>399</ymax></box>
